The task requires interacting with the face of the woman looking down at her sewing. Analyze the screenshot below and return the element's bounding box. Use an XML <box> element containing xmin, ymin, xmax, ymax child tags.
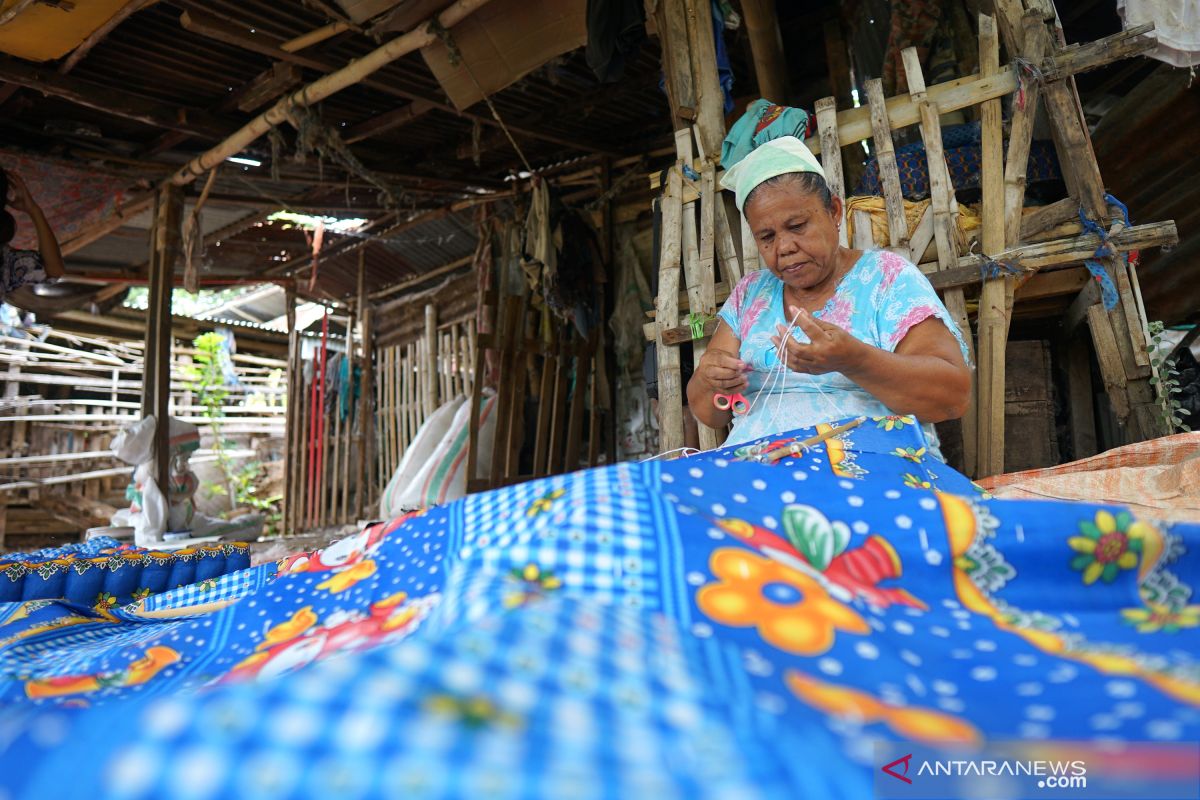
<box><xmin>745</xmin><ymin>181</ymin><xmax>841</xmax><ymax>290</ymax></box>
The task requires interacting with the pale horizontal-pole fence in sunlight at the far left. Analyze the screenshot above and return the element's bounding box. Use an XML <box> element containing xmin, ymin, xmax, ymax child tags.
<box><xmin>0</xmin><ymin>326</ymin><xmax>287</xmax><ymax>549</ymax></box>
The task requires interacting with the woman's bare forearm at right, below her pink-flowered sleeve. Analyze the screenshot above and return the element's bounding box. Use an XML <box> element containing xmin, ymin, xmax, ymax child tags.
<box><xmin>844</xmin><ymin>345</ymin><xmax>971</xmax><ymax>422</ymax></box>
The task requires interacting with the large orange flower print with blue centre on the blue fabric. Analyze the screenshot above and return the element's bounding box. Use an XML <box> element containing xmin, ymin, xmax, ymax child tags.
<box><xmin>696</xmin><ymin>547</ymin><xmax>871</xmax><ymax>656</ymax></box>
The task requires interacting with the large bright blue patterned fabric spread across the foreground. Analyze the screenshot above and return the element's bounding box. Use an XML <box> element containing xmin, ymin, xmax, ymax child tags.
<box><xmin>0</xmin><ymin>416</ymin><xmax>1200</xmax><ymax>800</ymax></box>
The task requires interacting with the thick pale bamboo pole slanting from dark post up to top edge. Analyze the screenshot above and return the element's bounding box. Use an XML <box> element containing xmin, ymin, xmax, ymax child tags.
<box><xmin>169</xmin><ymin>0</ymin><xmax>488</xmax><ymax>186</ymax></box>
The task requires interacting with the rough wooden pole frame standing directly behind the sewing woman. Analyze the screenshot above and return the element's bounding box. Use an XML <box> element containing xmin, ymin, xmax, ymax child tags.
<box><xmin>646</xmin><ymin>0</ymin><xmax>1177</xmax><ymax>475</ymax></box>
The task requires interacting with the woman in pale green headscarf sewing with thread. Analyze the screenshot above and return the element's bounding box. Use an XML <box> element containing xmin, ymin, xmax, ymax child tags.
<box><xmin>688</xmin><ymin>137</ymin><xmax>971</xmax><ymax>449</ymax></box>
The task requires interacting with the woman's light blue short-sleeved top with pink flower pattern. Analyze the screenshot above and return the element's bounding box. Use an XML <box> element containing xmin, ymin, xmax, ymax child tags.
<box><xmin>719</xmin><ymin>251</ymin><xmax>968</xmax><ymax>451</ymax></box>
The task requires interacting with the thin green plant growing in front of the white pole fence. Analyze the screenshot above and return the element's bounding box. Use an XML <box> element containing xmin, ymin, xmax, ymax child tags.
<box><xmin>185</xmin><ymin>333</ymin><xmax>281</xmax><ymax>533</ymax></box>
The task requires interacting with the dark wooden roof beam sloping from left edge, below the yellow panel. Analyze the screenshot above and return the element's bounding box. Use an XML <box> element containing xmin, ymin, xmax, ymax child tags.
<box><xmin>0</xmin><ymin>59</ymin><xmax>236</xmax><ymax>140</ymax></box>
